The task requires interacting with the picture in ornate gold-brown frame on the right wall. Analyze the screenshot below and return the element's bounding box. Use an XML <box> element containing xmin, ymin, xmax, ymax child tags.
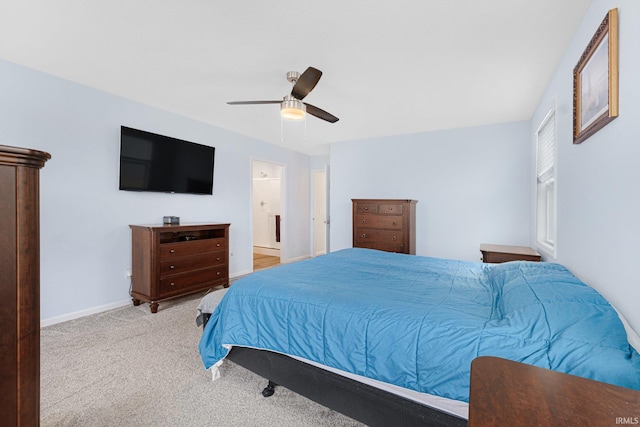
<box><xmin>573</xmin><ymin>8</ymin><xmax>618</xmax><ymax>144</ymax></box>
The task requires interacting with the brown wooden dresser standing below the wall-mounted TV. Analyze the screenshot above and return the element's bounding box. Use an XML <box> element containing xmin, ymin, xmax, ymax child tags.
<box><xmin>129</xmin><ymin>223</ymin><xmax>230</xmax><ymax>313</ymax></box>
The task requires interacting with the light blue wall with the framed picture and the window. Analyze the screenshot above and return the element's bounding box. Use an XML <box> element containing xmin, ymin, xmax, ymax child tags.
<box><xmin>530</xmin><ymin>0</ymin><xmax>640</xmax><ymax>331</ymax></box>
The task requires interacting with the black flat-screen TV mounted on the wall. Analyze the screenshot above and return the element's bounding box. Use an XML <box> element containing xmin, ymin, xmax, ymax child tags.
<box><xmin>120</xmin><ymin>126</ymin><xmax>215</xmax><ymax>194</ymax></box>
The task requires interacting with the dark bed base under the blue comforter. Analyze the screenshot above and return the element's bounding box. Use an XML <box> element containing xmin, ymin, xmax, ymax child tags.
<box><xmin>203</xmin><ymin>315</ymin><xmax>467</xmax><ymax>427</ymax></box>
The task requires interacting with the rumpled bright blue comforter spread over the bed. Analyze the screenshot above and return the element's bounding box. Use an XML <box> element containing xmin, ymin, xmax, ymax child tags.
<box><xmin>199</xmin><ymin>248</ymin><xmax>640</xmax><ymax>401</ymax></box>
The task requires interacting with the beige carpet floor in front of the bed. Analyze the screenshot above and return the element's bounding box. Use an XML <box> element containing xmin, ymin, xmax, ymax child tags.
<box><xmin>40</xmin><ymin>295</ymin><xmax>362</xmax><ymax>427</ymax></box>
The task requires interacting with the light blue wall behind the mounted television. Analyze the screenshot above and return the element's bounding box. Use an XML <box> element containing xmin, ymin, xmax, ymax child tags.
<box><xmin>0</xmin><ymin>60</ymin><xmax>310</xmax><ymax>321</ymax></box>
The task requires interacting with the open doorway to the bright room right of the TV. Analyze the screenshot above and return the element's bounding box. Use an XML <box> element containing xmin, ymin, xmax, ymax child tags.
<box><xmin>252</xmin><ymin>160</ymin><xmax>284</xmax><ymax>270</ymax></box>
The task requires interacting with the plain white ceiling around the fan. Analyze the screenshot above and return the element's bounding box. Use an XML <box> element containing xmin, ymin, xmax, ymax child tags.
<box><xmin>0</xmin><ymin>0</ymin><xmax>591</xmax><ymax>154</ymax></box>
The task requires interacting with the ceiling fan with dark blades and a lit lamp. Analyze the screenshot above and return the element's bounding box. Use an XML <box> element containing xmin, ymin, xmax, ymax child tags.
<box><xmin>227</xmin><ymin>67</ymin><xmax>339</xmax><ymax>123</ymax></box>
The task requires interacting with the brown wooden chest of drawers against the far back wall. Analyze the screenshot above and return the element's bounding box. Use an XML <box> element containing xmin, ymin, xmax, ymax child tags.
<box><xmin>351</xmin><ymin>199</ymin><xmax>418</xmax><ymax>255</ymax></box>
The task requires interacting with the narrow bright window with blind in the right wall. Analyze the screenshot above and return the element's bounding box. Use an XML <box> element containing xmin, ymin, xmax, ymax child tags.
<box><xmin>536</xmin><ymin>110</ymin><xmax>556</xmax><ymax>258</ymax></box>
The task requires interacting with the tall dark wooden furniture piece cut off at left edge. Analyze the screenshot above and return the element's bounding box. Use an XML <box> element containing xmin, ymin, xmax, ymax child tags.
<box><xmin>0</xmin><ymin>145</ymin><xmax>51</xmax><ymax>426</ymax></box>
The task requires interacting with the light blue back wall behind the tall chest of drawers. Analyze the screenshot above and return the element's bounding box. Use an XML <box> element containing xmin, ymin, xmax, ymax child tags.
<box><xmin>330</xmin><ymin>122</ymin><xmax>532</xmax><ymax>261</ymax></box>
